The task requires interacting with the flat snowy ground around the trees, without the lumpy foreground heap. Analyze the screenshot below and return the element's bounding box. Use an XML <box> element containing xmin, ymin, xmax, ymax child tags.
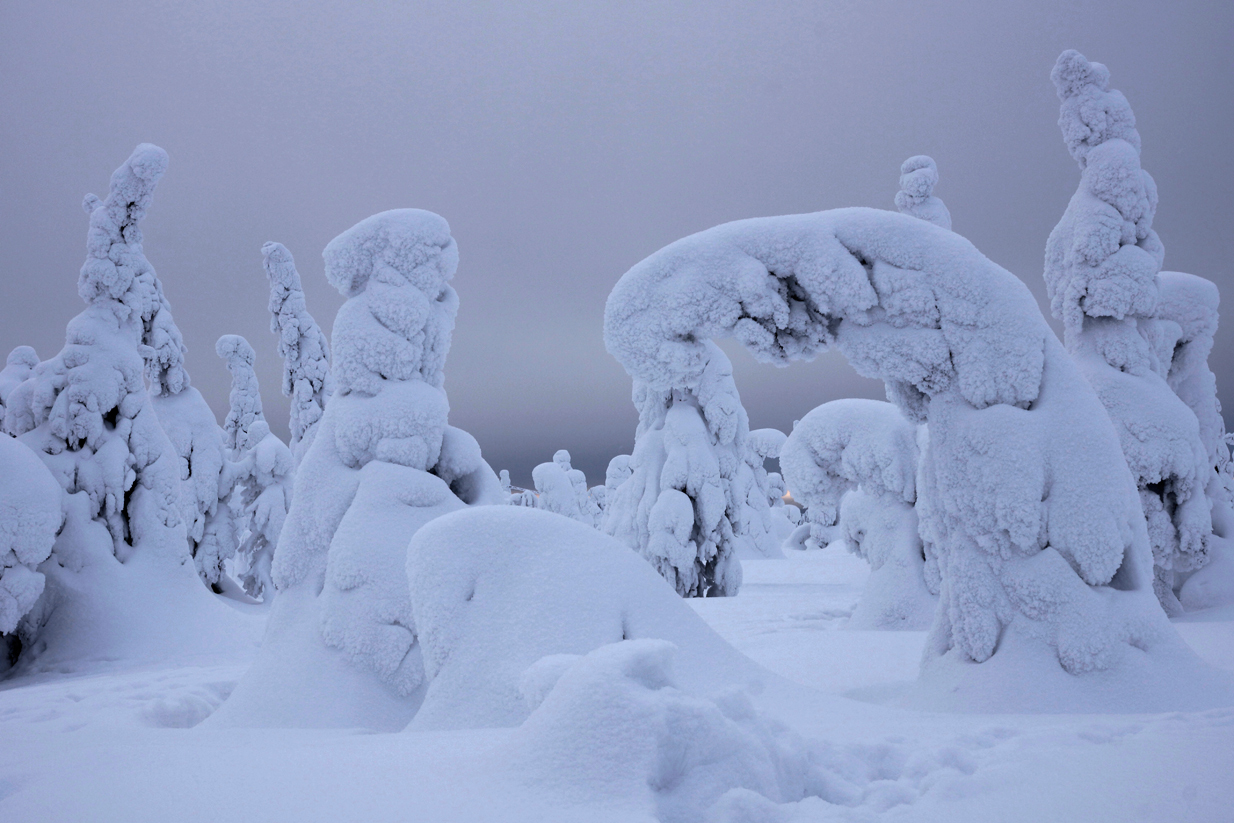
<box><xmin>0</xmin><ymin>547</ymin><xmax>1234</xmax><ymax>823</ymax></box>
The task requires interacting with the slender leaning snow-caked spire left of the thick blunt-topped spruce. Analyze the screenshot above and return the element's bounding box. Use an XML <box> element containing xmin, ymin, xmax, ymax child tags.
<box><xmin>262</xmin><ymin>242</ymin><xmax>334</xmax><ymax>464</ymax></box>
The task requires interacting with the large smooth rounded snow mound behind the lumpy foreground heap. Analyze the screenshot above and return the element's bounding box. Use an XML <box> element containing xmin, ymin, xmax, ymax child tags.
<box><xmin>407</xmin><ymin>506</ymin><xmax>768</xmax><ymax>729</ymax></box>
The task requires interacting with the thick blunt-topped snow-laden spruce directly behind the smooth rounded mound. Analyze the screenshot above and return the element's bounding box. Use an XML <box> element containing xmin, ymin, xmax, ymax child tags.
<box><xmin>211</xmin><ymin>209</ymin><xmax>505</xmax><ymax>729</ymax></box>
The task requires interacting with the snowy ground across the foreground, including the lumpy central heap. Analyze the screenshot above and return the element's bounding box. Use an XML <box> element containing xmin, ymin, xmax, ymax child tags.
<box><xmin>0</xmin><ymin>547</ymin><xmax>1234</xmax><ymax>823</ymax></box>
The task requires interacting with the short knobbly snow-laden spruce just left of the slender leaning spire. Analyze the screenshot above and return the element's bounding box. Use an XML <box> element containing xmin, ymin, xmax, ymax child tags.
<box><xmin>215</xmin><ymin>334</ymin><xmax>295</xmax><ymax>600</ymax></box>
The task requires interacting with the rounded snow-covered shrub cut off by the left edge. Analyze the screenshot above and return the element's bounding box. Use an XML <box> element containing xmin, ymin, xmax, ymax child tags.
<box><xmin>0</xmin><ymin>434</ymin><xmax>64</xmax><ymax>641</ymax></box>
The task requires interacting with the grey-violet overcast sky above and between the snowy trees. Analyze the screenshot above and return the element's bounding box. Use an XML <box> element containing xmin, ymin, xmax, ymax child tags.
<box><xmin>0</xmin><ymin>0</ymin><xmax>1234</xmax><ymax>482</ymax></box>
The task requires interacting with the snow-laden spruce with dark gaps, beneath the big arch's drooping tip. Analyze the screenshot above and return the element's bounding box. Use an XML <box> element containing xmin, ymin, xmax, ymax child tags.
<box><xmin>603</xmin><ymin>343</ymin><xmax>779</xmax><ymax>597</ymax></box>
